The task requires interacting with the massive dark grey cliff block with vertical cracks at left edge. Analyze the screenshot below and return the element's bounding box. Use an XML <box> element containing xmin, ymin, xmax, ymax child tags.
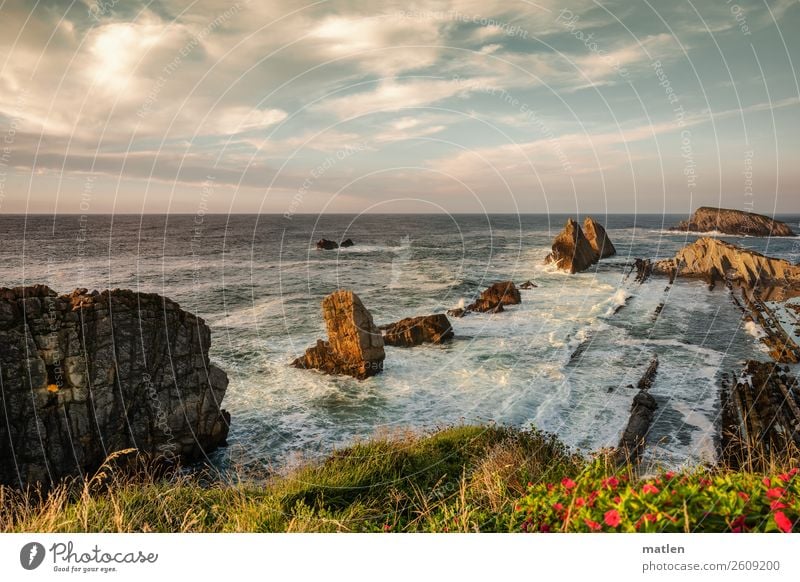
<box><xmin>0</xmin><ymin>285</ymin><xmax>230</xmax><ymax>487</ymax></box>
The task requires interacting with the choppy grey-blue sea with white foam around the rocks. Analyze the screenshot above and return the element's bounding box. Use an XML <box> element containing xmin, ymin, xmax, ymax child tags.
<box><xmin>0</xmin><ymin>215</ymin><xmax>800</xmax><ymax>468</ymax></box>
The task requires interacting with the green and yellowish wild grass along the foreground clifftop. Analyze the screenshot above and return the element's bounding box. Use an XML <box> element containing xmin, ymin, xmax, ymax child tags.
<box><xmin>0</xmin><ymin>426</ymin><xmax>798</xmax><ymax>532</ymax></box>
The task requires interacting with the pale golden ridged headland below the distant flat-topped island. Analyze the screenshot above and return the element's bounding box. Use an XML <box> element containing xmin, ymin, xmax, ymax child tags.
<box><xmin>653</xmin><ymin>237</ymin><xmax>800</xmax><ymax>287</ymax></box>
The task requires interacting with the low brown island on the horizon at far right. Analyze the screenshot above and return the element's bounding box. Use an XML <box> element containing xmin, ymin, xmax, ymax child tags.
<box><xmin>671</xmin><ymin>206</ymin><xmax>794</xmax><ymax>236</ymax></box>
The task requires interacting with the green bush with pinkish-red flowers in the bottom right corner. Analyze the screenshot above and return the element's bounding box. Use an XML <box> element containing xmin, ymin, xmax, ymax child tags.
<box><xmin>515</xmin><ymin>462</ymin><xmax>800</xmax><ymax>532</ymax></box>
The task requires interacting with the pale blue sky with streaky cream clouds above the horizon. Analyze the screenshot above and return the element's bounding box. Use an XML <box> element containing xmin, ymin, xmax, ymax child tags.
<box><xmin>0</xmin><ymin>0</ymin><xmax>800</xmax><ymax>218</ymax></box>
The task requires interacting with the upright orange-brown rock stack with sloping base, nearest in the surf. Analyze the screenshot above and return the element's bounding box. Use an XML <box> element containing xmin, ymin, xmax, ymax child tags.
<box><xmin>292</xmin><ymin>290</ymin><xmax>386</xmax><ymax>379</ymax></box>
